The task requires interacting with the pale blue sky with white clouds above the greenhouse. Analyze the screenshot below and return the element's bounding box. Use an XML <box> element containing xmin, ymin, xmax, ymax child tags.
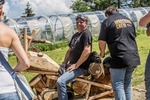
<box><xmin>4</xmin><ymin>0</ymin><xmax>74</xmax><ymax>18</ymax></box>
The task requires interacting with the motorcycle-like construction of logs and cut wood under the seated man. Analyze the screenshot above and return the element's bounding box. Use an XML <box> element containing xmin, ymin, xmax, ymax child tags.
<box><xmin>21</xmin><ymin>28</ymin><xmax>113</xmax><ymax>100</ymax></box>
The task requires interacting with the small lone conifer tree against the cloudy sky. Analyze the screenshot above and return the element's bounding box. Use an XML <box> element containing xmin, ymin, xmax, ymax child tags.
<box><xmin>22</xmin><ymin>2</ymin><xmax>35</xmax><ymax>17</ymax></box>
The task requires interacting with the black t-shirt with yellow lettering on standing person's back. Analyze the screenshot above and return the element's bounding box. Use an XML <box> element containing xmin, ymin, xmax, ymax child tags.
<box><xmin>99</xmin><ymin>13</ymin><xmax>140</xmax><ymax>68</ymax></box>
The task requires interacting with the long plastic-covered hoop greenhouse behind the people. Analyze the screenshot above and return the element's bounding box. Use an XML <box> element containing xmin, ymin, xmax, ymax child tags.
<box><xmin>4</xmin><ymin>7</ymin><xmax>150</xmax><ymax>42</ymax></box>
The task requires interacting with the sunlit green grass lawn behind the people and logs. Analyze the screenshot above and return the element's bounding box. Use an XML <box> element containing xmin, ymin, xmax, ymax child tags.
<box><xmin>9</xmin><ymin>34</ymin><xmax>150</xmax><ymax>86</ymax></box>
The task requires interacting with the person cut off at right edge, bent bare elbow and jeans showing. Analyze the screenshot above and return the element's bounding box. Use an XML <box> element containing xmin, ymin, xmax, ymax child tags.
<box><xmin>139</xmin><ymin>11</ymin><xmax>150</xmax><ymax>100</ymax></box>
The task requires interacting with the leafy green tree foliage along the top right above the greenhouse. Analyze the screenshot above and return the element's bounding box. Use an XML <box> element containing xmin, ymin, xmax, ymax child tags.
<box><xmin>70</xmin><ymin>0</ymin><xmax>150</xmax><ymax>12</ymax></box>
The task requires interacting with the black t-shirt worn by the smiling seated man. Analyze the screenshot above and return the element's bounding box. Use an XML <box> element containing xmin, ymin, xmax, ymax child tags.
<box><xmin>69</xmin><ymin>29</ymin><xmax>92</xmax><ymax>69</ymax></box>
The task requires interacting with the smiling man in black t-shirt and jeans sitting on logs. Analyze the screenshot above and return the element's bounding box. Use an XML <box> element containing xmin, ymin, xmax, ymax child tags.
<box><xmin>57</xmin><ymin>15</ymin><xmax>92</xmax><ymax>100</ymax></box>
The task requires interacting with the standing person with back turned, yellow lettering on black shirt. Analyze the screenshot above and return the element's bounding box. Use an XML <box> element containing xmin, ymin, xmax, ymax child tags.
<box><xmin>98</xmin><ymin>7</ymin><xmax>140</xmax><ymax>100</ymax></box>
